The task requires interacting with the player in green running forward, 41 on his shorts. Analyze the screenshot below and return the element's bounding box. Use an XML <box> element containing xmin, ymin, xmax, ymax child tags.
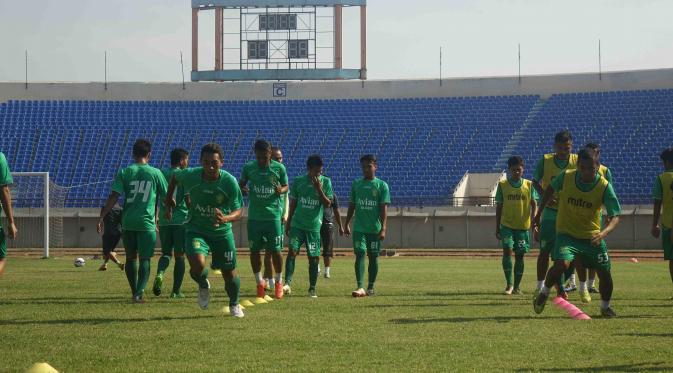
<box><xmin>166</xmin><ymin>144</ymin><xmax>244</xmax><ymax>317</ymax></box>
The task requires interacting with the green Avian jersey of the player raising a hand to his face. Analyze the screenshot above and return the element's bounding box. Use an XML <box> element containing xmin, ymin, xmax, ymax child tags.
<box><xmin>290</xmin><ymin>175</ymin><xmax>332</xmax><ymax>232</ymax></box>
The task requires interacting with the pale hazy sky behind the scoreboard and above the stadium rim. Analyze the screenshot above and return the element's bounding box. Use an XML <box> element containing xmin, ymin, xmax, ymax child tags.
<box><xmin>0</xmin><ymin>0</ymin><xmax>673</xmax><ymax>82</ymax></box>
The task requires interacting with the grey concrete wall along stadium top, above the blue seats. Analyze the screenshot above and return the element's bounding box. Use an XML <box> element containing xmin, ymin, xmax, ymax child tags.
<box><xmin>0</xmin><ymin>69</ymin><xmax>673</xmax><ymax>102</ymax></box>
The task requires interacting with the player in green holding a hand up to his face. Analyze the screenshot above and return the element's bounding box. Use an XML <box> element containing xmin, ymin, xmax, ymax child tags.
<box><xmin>284</xmin><ymin>154</ymin><xmax>332</xmax><ymax>298</ymax></box>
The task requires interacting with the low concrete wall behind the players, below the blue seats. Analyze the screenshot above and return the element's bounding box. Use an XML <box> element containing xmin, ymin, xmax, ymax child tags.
<box><xmin>1</xmin><ymin>206</ymin><xmax>661</xmax><ymax>250</ymax></box>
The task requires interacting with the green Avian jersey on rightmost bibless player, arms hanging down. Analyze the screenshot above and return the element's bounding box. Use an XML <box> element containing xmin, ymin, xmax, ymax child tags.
<box><xmin>350</xmin><ymin>178</ymin><xmax>390</xmax><ymax>233</ymax></box>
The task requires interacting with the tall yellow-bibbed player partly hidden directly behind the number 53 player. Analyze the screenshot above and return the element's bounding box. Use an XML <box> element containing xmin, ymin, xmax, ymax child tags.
<box><xmin>533</xmin><ymin>130</ymin><xmax>577</xmax><ymax>295</ymax></box>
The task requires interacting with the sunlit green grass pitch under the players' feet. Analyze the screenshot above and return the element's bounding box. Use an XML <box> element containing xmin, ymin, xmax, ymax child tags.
<box><xmin>0</xmin><ymin>256</ymin><xmax>673</xmax><ymax>372</ymax></box>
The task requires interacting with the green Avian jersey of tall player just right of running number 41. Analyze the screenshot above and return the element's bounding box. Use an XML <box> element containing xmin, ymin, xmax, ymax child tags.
<box><xmin>241</xmin><ymin>160</ymin><xmax>287</xmax><ymax>221</ymax></box>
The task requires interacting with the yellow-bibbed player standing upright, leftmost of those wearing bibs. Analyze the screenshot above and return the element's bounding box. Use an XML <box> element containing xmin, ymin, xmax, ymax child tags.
<box><xmin>495</xmin><ymin>156</ymin><xmax>538</xmax><ymax>295</ymax></box>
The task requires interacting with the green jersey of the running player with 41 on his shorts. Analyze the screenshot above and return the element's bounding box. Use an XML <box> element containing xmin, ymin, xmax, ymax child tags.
<box><xmin>174</xmin><ymin>167</ymin><xmax>243</xmax><ymax>235</ymax></box>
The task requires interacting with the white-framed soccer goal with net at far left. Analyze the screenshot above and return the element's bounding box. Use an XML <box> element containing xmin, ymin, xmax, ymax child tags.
<box><xmin>3</xmin><ymin>172</ymin><xmax>68</xmax><ymax>258</ymax></box>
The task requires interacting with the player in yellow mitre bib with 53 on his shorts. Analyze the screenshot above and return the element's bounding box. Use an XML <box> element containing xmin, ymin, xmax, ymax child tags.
<box><xmin>533</xmin><ymin>149</ymin><xmax>621</xmax><ymax>317</ymax></box>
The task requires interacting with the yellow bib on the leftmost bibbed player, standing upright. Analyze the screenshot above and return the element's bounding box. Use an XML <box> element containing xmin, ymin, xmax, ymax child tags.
<box><xmin>500</xmin><ymin>179</ymin><xmax>533</xmax><ymax>230</ymax></box>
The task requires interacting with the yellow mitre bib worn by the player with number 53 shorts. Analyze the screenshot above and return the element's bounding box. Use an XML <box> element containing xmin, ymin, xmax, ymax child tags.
<box><xmin>556</xmin><ymin>170</ymin><xmax>609</xmax><ymax>239</ymax></box>
